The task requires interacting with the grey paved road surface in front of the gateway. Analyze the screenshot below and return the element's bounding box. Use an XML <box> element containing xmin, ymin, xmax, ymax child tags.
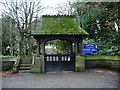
<box><xmin>2</xmin><ymin>69</ymin><xmax>118</xmax><ymax>88</ymax></box>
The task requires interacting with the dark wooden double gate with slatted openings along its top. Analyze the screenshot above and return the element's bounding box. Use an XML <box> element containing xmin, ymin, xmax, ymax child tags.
<box><xmin>45</xmin><ymin>54</ymin><xmax>75</xmax><ymax>72</ymax></box>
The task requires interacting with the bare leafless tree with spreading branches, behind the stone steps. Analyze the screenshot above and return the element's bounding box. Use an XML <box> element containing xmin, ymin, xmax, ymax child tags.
<box><xmin>1</xmin><ymin>0</ymin><xmax>44</xmax><ymax>57</ymax></box>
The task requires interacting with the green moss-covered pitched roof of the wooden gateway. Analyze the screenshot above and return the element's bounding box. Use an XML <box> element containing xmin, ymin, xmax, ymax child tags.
<box><xmin>32</xmin><ymin>15</ymin><xmax>88</xmax><ymax>35</ymax></box>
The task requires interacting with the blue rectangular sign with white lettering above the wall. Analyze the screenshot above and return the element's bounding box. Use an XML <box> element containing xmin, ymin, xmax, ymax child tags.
<box><xmin>82</xmin><ymin>44</ymin><xmax>98</xmax><ymax>55</ymax></box>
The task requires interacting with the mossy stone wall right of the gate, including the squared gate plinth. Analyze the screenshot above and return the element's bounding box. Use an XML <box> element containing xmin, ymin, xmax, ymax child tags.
<box><xmin>75</xmin><ymin>56</ymin><xmax>120</xmax><ymax>71</ymax></box>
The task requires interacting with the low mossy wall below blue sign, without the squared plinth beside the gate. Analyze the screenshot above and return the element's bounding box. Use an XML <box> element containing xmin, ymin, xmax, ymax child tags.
<box><xmin>85</xmin><ymin>55</ymin><xmax>120</xmax><ymax>69</ymax></box>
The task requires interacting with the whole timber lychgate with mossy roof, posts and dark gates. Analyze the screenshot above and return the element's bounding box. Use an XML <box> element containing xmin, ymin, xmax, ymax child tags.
<box><xmin>32</xmin><ymin>15</ymin><xmax>88</xmax><ymax>72</ymax></box>
